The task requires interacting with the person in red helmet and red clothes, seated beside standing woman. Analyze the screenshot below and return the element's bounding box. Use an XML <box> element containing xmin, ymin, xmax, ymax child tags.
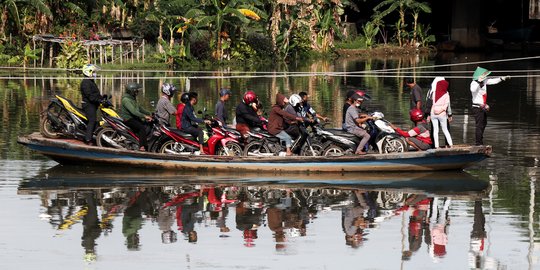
<box><xmin>390</xmin><ymin>108</ymin><xmax>432</xmax><ymax>151</ymax></box>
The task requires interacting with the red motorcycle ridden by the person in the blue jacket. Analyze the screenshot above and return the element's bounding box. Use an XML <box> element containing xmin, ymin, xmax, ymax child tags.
<box><xmin>156</xmin><ymin>119</ymin><xmax>243</xmax><ymax>156</ymax></box>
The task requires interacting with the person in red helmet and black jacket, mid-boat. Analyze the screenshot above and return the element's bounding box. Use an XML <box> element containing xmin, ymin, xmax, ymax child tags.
<box><xmin>235</xmin><ymin>91</ymin><xmax>263</xmax><ymax>136</ymax></box>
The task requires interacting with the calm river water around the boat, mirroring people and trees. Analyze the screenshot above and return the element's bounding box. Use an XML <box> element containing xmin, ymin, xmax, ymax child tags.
<box><xmin>0</xmin><ymin>54</ymin><xmax>540</xmax><ymax>269</ymax></box>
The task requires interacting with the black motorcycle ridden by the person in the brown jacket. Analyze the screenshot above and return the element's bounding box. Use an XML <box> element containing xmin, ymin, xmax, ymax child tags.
<box><xmin>244</xmin><ymin>124</ymin><xmax>324</xmax><ymax>156</ymax></box>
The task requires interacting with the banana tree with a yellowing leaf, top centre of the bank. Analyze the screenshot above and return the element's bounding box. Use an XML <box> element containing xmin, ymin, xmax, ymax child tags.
<box><xmin>185</xmin><ymin>0</ymin><xmax>266</xmax><ymax>60</ymax></box>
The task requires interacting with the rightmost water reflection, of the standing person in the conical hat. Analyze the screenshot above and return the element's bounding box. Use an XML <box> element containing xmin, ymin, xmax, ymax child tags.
<box><xmin>469</xmin><ymin>199</ymin><xmax>487</xmax><ymax>269</ymax></box>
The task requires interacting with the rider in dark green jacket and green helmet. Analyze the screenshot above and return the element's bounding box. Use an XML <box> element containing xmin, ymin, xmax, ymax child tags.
<box><xmin>120</xmin><ymin>82</ymin><xmax>152</xmax><ymax>151</ymax></box>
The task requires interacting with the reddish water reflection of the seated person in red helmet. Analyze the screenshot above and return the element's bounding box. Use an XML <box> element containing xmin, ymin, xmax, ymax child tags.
<box><xmin>398</xmin><ymin>195</ymin><xmax>432</xmax><ymax>260</ymax></box>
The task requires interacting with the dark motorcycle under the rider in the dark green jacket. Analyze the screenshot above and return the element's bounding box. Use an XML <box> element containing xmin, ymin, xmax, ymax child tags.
<box><xmin>96</xmin><ymin>112</ymin><xmax>161</xmax><ymax>152</ymax></box>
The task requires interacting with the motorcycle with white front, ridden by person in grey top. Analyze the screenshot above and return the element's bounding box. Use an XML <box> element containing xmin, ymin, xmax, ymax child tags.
<box><xmin>315</xmin><ymin>112</ymin><xmax>408</xmax><ymax>156</ymax></box>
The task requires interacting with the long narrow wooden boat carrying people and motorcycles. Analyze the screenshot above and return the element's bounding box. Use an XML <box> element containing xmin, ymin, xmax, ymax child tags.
<box><xmin>17</xmin><ymin>133</ymin><xmax>491</xmax><ymax>173</ymax></box>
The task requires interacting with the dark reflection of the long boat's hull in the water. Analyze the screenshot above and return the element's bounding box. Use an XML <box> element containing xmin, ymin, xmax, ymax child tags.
<box><xmin>19</xmin><ymin>165</ymin><xmax>488</xmax><ymax>195</ymax></box>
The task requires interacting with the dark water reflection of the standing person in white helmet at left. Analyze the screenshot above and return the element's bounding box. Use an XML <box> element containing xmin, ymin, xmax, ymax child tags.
<box><xmin>81</xmin><ymin>191</ymin><xmax>101</xmax><ymax>261</ymax></box>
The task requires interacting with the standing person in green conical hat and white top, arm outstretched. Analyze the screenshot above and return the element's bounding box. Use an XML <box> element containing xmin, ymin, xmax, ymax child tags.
<box><xmin>470</xmin><ymin>67</ymin><xmax>510</xmax><ymax>145</ymax></box>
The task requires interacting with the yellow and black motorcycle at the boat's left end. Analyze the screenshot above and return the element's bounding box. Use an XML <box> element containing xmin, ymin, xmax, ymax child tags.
<box><xmin>40</xmin><ymin>95</ymin><xmax>119</xmax><ymax>140</ymax></box>
